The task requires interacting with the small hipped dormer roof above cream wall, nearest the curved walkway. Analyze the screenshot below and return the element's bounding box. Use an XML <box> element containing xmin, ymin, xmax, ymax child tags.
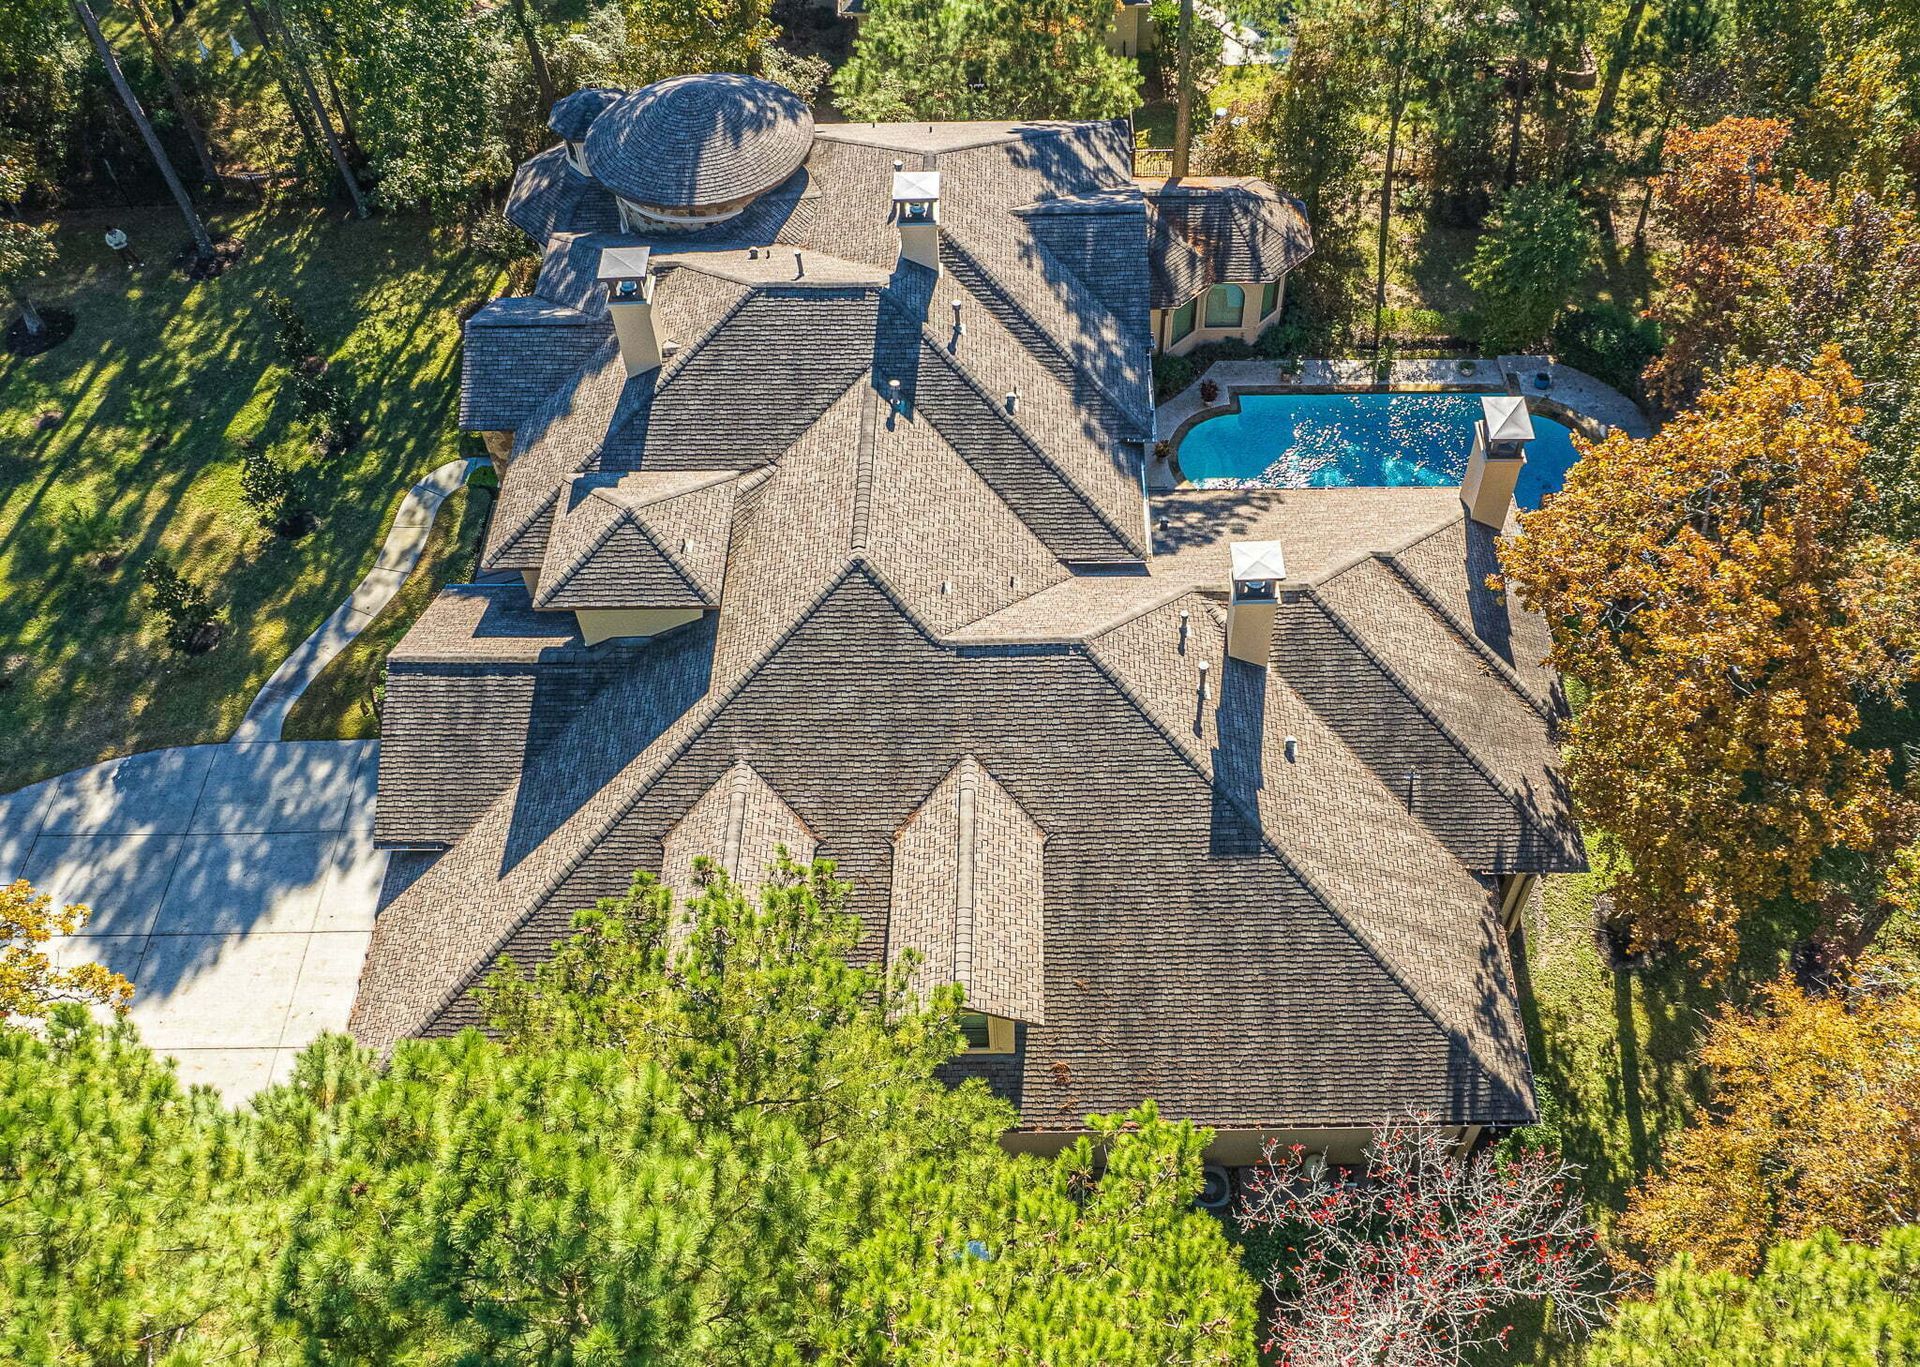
<box><xmin>534</xmin><ymin>470</ymin><xmax>733</xmax><ymax>609</ymax></box>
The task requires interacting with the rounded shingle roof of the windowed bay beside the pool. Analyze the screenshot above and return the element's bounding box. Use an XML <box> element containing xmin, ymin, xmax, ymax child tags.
<box><xmin>1140</xmin><ymin>177</ymin><xmax>1313</xmax><ymax>309</ymax></box>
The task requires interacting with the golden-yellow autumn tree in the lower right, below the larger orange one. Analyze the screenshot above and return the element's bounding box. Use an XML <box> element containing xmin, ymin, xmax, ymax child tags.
<box><xmin>1615</xmin><ymin>966</ymin><xmax>1920</xmax><ymax>1273</ymax></box>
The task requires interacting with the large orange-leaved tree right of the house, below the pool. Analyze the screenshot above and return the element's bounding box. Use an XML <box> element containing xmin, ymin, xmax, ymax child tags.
<box><xmin>1505</xmin><ymin>349</ymin><xmax>1920</xmax><ymax>968</ymax></box>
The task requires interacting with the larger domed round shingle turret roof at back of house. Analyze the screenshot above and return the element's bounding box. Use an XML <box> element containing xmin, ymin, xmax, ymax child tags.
<box><xmin>586</xmin><ymin>75</ymin><xmax>814</xmax><ymax>209</ymax></box>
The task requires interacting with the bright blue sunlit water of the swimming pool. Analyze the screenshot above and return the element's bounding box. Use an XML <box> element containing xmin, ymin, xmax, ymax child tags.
<box><xmin>1179</xmin><ymin>394</ymin><xmax>1578</xmax><ymax>509</ymax></box>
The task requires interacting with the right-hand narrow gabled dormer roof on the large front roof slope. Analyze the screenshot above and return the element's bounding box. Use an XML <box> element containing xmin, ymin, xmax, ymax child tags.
<box><xmin>887</xmin><ymin>755</ymin><xmax>1046</xmax><ymax>1025</ymax></box>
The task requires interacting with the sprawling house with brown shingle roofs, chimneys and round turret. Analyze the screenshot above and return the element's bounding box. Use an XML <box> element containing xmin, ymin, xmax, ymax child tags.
<box><xmin>353</xmin><ymin>77</ymin><xmax>1582</xmax><ymax>1162</ymax></box>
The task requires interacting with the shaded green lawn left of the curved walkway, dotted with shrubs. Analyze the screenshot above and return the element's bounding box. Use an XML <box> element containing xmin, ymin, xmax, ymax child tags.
<box><xmin>0</xmin><ymin>197</ymin><xmax>501</xmax><ymax>791</ymax></box>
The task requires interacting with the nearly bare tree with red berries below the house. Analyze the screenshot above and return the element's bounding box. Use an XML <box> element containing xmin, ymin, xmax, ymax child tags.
<box><xmin>1238</xmin><ymin>1115</ymin><xmax>1611</xmax><ymax>1367</ymax></box>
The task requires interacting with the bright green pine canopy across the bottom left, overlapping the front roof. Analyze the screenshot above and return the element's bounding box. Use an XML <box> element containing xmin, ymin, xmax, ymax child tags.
<box><xmin>0</xmin><ymin>862</ymin><xmax>1256</xmax><ymax>1365</ymax></box>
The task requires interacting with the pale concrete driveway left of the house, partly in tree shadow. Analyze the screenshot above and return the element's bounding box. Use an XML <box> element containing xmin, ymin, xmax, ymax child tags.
<box><xmin>0</xmin><ymin>741</ymin><xmax>388</xmax><ymax>1102</ymax></box>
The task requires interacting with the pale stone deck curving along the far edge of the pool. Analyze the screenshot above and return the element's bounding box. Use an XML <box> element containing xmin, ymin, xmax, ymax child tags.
<box><xmin>1146</xmin><ymin>355</ymin><xmax>1653</xmax><ymax>490</ymax></box>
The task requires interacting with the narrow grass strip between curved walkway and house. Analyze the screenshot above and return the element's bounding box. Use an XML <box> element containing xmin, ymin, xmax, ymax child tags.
<box><xmin>282</xmin><ymin>486</ymin><xmax>493</xmax><ymax>741</ymax></box>
